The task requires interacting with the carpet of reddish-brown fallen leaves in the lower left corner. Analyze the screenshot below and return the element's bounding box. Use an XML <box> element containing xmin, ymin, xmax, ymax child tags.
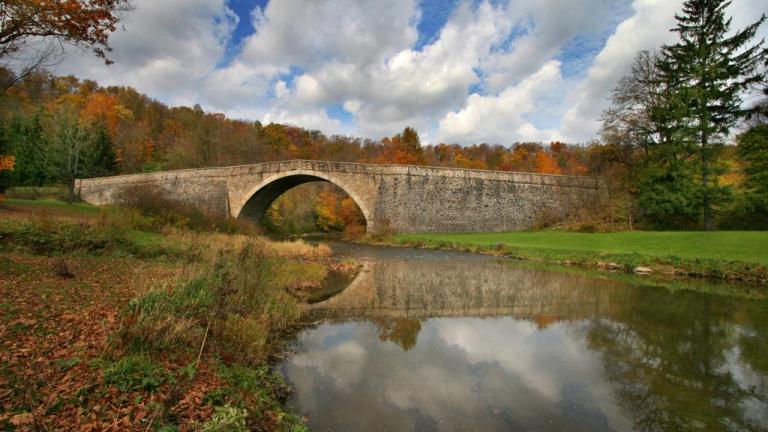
<box><xmin>0</xmin><ymin>253</ymin><xmax>189</xmax><ymax>431</ymax></box>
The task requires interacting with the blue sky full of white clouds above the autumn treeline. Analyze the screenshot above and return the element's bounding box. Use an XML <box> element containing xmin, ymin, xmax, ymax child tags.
<box><xmin>56</xmin><ymin>0</ymin><xmax>768</xmax><ymax>144</ymax></box>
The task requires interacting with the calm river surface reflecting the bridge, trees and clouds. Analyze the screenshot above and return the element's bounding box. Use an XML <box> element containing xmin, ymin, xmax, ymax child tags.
<box><xmin>282</xmin><ymin>244</ymin><xmax>768</xmax><ymax>431</ymax></box>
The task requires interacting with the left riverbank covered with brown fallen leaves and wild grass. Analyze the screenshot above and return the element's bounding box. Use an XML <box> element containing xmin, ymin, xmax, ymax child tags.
<box><xmin>0</xmin><ymin>200</ymin><xmax>351</xmax><ymax>431</ymax></box>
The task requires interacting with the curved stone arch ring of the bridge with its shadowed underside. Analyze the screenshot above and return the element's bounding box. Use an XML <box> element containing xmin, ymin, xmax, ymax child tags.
<box><xmin>231</xmin><ymin>170</ymin><xmax>373</xmax><ymax>231</ymax></box>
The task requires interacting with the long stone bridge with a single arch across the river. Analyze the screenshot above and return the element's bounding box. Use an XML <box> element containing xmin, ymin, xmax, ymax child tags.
<box><xmin>75</xmin><ymin>160</ymin><xmax>604</xmax><ymax>233</ymax></box>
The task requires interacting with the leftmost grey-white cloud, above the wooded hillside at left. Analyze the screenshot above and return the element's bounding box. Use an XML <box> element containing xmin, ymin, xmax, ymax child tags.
<box><xmin>56</xmin><ymin>0</ymin><xmax>237</xmax><ymax>104</ymax></box>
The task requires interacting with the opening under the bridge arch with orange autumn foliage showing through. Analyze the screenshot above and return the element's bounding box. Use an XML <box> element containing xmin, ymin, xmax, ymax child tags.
<box><xmin>237</xmin><ymin>174</ymin><xmax>370</xmax><ymax>234</ymax></box>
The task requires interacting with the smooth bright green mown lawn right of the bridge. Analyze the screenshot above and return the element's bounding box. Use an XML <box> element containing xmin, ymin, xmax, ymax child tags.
<box><xmin>395</xmin><ymin>231</ymin><xmax>768</xmax><ymax>265</ymax></box>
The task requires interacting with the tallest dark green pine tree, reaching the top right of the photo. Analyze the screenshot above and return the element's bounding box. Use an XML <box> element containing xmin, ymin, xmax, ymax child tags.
<box><xmin>652</xmin><ymin>0</ymin><xmax>766</xmax><ymax>229</ymax></box>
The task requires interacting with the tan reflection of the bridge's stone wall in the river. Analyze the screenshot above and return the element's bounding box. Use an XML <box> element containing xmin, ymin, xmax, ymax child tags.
<box><xmin>312</xmin><ymin>259</ymin><xmax>628</xmax><ymax>322</ymax></box>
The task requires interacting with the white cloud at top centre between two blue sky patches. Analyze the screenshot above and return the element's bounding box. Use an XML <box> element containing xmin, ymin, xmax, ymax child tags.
<box><xmin>240</xmin><ymin>0</ymin><xmax>418</xmax><ymax>69</ymax></box>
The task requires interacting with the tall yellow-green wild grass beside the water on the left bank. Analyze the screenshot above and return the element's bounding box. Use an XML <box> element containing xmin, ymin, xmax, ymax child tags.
<box><xmin>114</xmin><ymin>242</ymin><xmax>318</xmax><ymax>430</ymax></box>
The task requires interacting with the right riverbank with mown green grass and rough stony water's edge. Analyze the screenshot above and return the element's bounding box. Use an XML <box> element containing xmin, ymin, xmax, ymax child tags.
<box><xmin>388</xmin><ymin>231</ymin><xmax>768</xmax><ymax>285</ymax></box>
